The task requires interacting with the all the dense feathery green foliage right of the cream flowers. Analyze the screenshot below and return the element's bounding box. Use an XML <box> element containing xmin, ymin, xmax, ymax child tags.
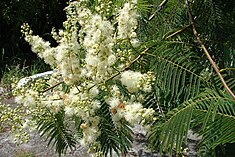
<box><xmin>143</xmin><ymin>0</ymin><xmax>235</xmax><ymax>156</ymax></box>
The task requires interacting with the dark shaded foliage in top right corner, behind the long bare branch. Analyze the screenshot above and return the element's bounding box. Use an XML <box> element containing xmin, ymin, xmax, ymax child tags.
<box><xmin>192</xmin><ymin>0</ymin><xmax>235</xmax><ymax>71</ymax></box>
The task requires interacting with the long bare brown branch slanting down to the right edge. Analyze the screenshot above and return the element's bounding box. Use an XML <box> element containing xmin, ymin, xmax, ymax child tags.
<box><xmin>185</xmin><ymin>0</ymin><xmax>235</xmax><ymax>100</ymax></box>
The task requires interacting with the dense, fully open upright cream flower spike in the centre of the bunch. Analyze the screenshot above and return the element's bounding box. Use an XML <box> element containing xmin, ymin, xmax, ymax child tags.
<box><xmin>83</xmin><ymin>15</ymin><xmax>116</xmax><ymax>82</ymax></box>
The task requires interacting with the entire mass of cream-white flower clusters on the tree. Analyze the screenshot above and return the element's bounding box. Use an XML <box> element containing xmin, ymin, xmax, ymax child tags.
<box><xmin>17</xmin><ymin>0</ymin><xmax>157</xmax><ymax>148</ymax></box>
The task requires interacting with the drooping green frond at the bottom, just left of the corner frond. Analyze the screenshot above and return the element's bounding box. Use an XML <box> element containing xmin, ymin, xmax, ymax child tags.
<box><xmin>148</xmin><ymin>95</ymin><xmax>193</xmax><ymax>154</ymax></box>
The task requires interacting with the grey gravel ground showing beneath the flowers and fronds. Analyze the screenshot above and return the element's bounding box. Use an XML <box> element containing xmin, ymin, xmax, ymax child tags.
<box><xmin>0</xmin><ymin>87</ymin><xmax>200</xmax><ymax>157</ymax></box>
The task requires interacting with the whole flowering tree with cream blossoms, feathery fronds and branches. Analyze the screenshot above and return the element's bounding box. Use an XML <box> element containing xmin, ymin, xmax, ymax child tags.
<box><xmin>7</xmin><ymin>0</ymin><xmax>235</xmax><ymax>156</ymax></box>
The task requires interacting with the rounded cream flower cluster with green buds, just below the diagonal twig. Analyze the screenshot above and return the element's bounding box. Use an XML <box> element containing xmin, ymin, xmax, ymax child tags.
<box><xmin>121</xmin><ymin>70</ymin><xmax>155</xmax><ymax>93</ymax></box>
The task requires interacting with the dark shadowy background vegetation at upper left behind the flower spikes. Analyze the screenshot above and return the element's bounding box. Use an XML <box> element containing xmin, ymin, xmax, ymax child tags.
<box><xmin>0</xmin><ymin>0</ymin><xmax>66</xmax><ymax>77</ymax></box>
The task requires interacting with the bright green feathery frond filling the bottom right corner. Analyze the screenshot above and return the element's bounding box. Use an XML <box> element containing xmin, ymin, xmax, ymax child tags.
<box><xmin>194</xmin><ymin>91</ymin><xmax>235</xmax><ymax>156</ymax></box>
